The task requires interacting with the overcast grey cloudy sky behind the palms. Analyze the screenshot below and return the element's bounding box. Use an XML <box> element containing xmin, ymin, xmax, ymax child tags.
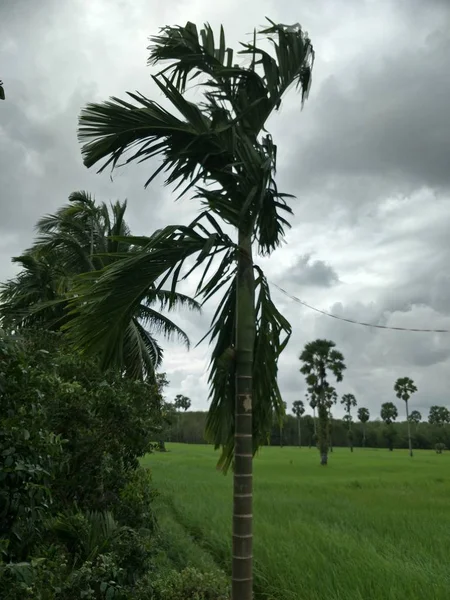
<box><xmin>0</xmin><ymin>0</ymin><xmax>450</xmax><ymax>416</ymax></box>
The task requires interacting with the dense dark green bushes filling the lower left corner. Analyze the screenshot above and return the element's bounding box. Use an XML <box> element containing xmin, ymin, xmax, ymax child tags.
<box><xmin>0</xmin><ymin>330</ymin><xmax>224</xmax><ymax>600</ymax></box>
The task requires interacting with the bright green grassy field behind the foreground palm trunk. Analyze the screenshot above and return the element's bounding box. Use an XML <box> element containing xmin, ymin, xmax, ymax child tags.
<box><xmin>145</xmin><ymin>444</ymin><xmax>450</xmax><ymax>600</ymax></box>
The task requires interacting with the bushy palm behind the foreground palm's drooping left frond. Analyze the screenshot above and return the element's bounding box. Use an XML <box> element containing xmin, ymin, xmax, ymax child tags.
<box><xmin>0</xmin><ymin>192</ymin><xmax>198</xmax><ymax>378</ymax></box>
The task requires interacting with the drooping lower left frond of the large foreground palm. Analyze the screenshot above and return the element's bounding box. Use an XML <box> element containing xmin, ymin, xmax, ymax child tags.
<box><xmin>66</xmin><ymin>221</ymin><xmax>234</xmax><ymax>364</ymax></box>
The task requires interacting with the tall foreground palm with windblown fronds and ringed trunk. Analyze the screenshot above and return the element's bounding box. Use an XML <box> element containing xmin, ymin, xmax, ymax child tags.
<box><xmin>67</xmin><ymin>22</ymin><xmax>314</xmax><ymax>600</ymax></box>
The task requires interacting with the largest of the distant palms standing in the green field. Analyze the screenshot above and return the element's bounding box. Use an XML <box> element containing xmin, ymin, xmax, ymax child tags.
<box><xmin>300</xmin><ymin>339</ymin><xmax>346</xmax><ymax>465</ymax></box>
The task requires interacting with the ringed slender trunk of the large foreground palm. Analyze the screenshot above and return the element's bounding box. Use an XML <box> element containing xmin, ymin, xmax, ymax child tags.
<box><xmin>231</xmin><ymin>232</ymin><xmax>256</xmax><ymax>600</ymax></box>
